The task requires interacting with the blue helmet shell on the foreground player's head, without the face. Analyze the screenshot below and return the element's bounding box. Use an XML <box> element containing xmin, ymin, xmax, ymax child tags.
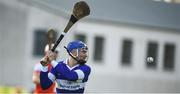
<box><xmin>67</xmin><ymin>40</ymin><xmax>87</xmax><ymax>52</ymax></box>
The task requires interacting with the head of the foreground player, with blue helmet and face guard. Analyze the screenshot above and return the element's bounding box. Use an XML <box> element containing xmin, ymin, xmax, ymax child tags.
<box><xmin>64</xmin><ymin>40</ymin><xmax>88</xmax><ymax>64</ymax></box>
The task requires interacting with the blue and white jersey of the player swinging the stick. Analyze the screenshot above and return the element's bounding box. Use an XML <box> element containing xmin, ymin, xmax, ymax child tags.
<box><xmin>40</xmin><ymin>60</ymin><xmax>91</xmax><ymax>93</ymax></box>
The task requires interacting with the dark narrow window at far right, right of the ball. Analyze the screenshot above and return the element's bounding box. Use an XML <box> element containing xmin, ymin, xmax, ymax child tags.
<box><xmin>163</xmin><ymin>44</ymin><xmax>175</xmax><ymax>70</ymax></box>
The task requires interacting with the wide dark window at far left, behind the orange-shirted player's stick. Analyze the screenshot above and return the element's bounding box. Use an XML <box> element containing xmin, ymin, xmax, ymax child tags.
<box><xmin>33</xmin><ymin>29</ymin><xmax>57</xmax><ymax>56</ymax></box>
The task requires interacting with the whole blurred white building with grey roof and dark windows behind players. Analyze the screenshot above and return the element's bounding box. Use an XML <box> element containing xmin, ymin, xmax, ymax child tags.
<box><xmin>0</xmin><ymin>0</ymin><xmax>180</xmax><ymax>93</ymax></box>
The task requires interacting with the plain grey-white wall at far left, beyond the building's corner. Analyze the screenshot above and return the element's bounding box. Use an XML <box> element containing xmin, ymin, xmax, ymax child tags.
<box><xmin>0</xmin><ymin>0</ymin><xmax>27</xmax><ymax>86</ymax></box>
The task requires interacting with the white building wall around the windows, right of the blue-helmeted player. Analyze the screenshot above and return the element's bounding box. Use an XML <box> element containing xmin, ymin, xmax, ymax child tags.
<box><xmin>77</xmin><ymin>23</ymin><xmax>180</xmax><ymax>92</ymax></box>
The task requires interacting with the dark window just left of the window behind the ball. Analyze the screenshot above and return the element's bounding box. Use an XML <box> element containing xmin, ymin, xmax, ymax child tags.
<box><xmin>121</xmin><ymin>39</ymin><xmax>132</xmax><ymax>65</ymax></box>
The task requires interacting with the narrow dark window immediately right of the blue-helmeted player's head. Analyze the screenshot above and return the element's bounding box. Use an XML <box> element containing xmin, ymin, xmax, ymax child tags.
<box><xmin>93</xmin><ymin>36</ymin><xmax>104</xmax><ymax>61</ymax></box>
